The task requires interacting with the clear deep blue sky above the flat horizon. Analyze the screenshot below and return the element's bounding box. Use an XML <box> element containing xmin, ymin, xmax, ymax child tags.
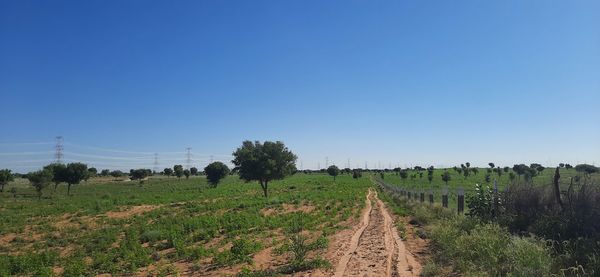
<box><xmin>0</xmin><ymin>0</ymin><xmax>600</xmax><ymax>171</ymax></box>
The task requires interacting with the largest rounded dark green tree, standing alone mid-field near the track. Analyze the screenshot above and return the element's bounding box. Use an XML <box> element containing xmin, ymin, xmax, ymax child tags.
<box><xmin>232</xmin><ymin>141</ymin><xmax>297</xmax><ymax>197</ymax></box>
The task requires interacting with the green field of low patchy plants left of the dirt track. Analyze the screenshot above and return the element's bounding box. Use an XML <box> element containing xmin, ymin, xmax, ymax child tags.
<box><xmin>0</xmin><ymin>174</ymin><xmax>372</xmax><ymax>276</ymax></box>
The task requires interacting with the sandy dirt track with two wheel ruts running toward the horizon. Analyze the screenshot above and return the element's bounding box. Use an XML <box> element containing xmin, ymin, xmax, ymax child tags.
<box><xmin>334</xmin><ymin>190</ymin><xmax>421</xmax><ymax>276</ymax></box>
